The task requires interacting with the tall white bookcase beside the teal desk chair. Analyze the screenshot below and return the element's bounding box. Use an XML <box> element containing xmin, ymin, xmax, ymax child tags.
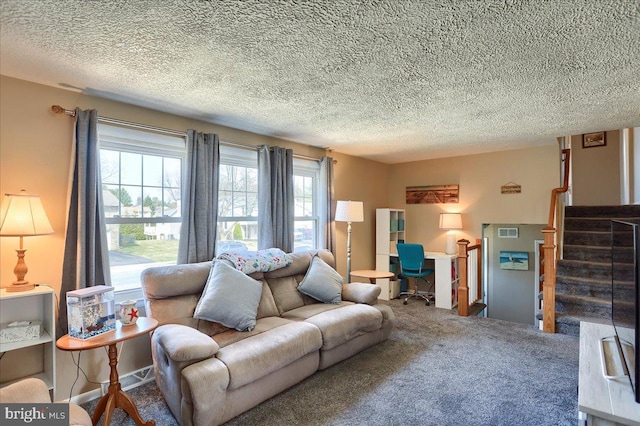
<box><xmin>376</xmin><ymin>209</ymin><xmax>406</xmax><ymax>300</ymax></box>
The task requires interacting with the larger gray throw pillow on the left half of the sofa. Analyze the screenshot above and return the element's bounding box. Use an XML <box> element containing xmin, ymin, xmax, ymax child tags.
<box><xmin>193</xmin><ymin>260</ymin><xmax>262</xmax><ymax>331</ymax></box>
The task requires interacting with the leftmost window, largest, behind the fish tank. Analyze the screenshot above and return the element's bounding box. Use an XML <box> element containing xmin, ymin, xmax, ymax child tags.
<box><xmin>98</xmin><ymin>123</ymin><xmax>185</xmax><ymax>292</ymax></box>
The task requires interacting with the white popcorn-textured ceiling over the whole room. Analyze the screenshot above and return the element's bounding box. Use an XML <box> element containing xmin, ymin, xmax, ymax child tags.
<box><xmin>0</xmin><ymin>0</ymin><xmax>640</xmax><ymax>163</ymax></box>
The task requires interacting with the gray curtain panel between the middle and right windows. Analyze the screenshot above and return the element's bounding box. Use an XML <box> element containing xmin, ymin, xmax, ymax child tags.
<box><xmin>258</xmin><ymin>146</ymin><xmax>295</xmax><ymax>253</ymax></box>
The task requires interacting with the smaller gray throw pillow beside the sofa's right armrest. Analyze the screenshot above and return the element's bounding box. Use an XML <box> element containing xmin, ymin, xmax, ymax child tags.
<box><xmin>298</xmin><ymin>254</ymin><xmax>344</xmax><ymax>303</ymax></box>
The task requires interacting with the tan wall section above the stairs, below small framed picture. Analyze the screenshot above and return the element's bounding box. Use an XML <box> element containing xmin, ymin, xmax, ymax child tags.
<box><xmin>571</xmin><ymin>130</ymin><xmax>620</xmax><ymax>206</ymax></box>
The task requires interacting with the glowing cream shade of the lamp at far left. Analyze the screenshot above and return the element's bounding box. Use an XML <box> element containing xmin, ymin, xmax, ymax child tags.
<box><xmin>0</xmin><ymin>193</ymin><xmax>53</xmax><ymax>237</ymax></box>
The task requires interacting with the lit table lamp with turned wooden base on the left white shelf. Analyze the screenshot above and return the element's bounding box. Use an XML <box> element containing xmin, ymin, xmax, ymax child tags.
<box><xmin>0</xmin><ymin>190</ymin><xmax>53</xmax><ymax>292</ymax></box>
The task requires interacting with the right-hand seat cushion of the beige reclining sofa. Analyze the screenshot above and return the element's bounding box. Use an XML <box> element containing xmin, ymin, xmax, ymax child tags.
<box><xmin>305</xmin><ymin>304</ymin><xmax>382</xmax><ymax>350</ymax></box>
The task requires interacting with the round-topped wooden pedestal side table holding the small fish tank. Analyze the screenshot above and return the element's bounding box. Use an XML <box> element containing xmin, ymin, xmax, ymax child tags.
<box><xmin>56</xmin><ymin>317</ymin><xmax>158</xmax><ymax>426</ymax></box>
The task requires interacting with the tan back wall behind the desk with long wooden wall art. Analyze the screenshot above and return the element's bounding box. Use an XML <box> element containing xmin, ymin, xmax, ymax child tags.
<box><xmin>388</xmin><ymin>146</ymin><xmax>560</xmax><ymax>251</ymax></box>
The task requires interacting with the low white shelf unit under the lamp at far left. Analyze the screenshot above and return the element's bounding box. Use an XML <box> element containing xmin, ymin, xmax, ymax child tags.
<box><xmin>0</xmin><ymin>285</ymin><xmax>56</xmax><ymax>401</ymax></box>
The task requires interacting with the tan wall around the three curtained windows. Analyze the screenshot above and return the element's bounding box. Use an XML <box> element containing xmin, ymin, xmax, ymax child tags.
<box><xmin>0</xmin><ymin>76</ymin><xmax>388</xmax><ymax>399</ymax></box>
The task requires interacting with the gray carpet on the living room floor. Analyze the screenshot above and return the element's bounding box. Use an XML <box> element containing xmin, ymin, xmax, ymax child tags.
<box><xmin>81</xmin><ymin>300</ymin><xmax>578</xmax><ymax>426</ymax></box>
